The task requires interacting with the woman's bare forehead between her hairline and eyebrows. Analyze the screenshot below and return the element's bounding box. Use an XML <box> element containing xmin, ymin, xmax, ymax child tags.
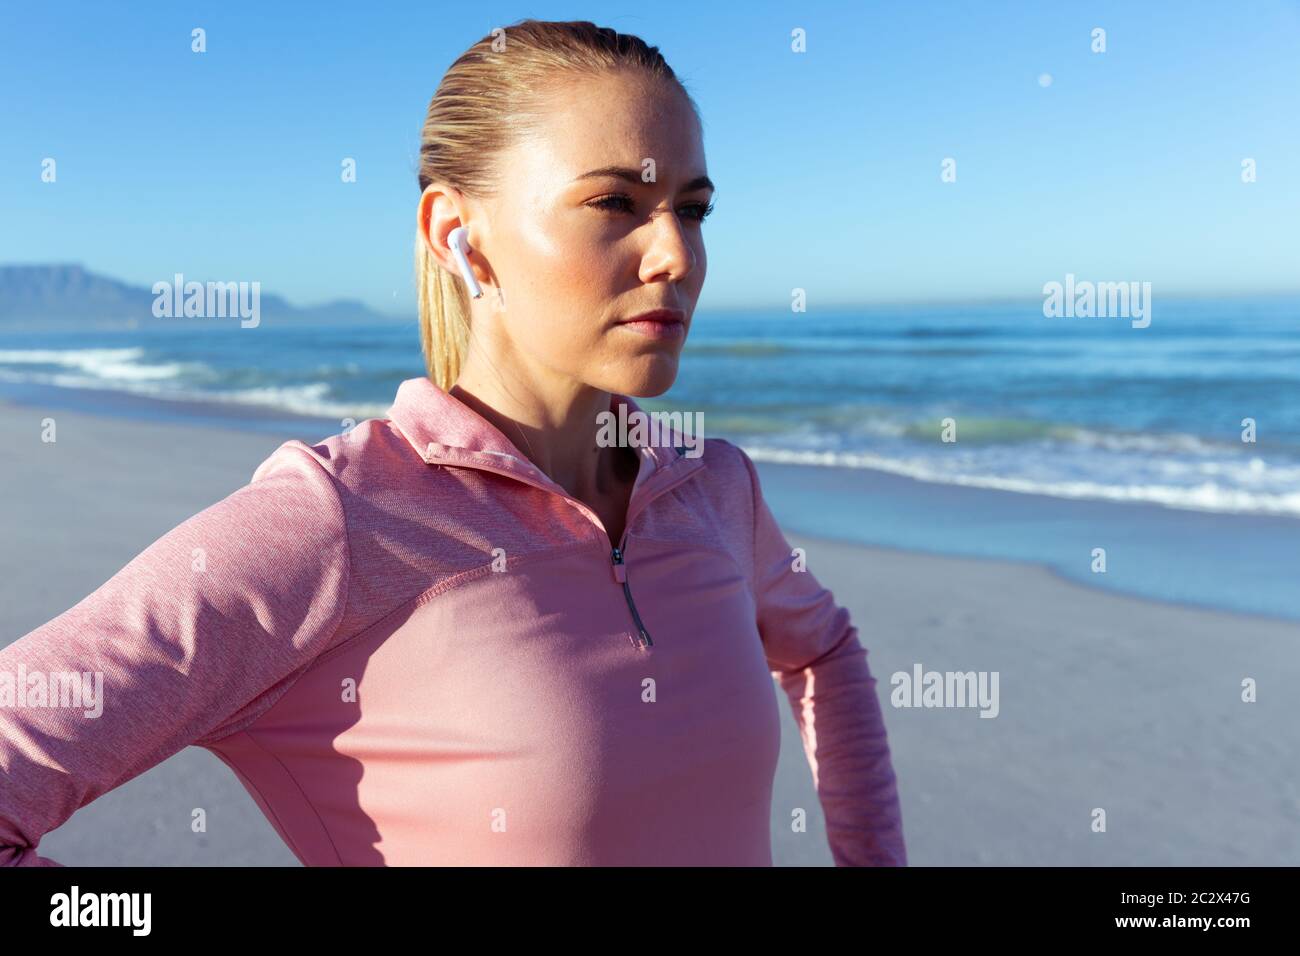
<box><xmin>507</xmin><ymin>73</ymin><xmax>707</xmax><ymax>191</ymax></box>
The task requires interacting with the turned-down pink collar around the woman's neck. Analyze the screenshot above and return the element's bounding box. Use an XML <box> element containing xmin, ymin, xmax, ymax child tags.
<box><xmin>389</xmin><ymin>376</ymin><xmax>685</xmax><ymax>485</ymax></box>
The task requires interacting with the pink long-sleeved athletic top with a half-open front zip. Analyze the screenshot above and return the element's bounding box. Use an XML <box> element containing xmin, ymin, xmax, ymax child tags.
<box><xmin>0</xmin><ymin>378</ymin><xmax>906</xmax><ymax>866</ymax></box>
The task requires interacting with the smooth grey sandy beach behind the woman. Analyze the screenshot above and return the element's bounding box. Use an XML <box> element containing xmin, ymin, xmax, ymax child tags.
<box><xmin>0</xmin><ymin>403</ymin><xmax>1300</xmax><ymax>866</ymax></box>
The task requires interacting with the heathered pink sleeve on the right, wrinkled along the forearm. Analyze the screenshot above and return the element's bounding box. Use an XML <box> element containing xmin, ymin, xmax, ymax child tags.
<box><xmin>741</xmin><ymin>451</ymin><xmax>907</xmax><ymax>866</ymax></box>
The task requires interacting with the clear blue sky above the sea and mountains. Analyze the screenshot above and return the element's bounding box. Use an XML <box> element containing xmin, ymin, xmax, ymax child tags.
<box><xmin>0</xmin><ymin>0</ymin><xmax>1300</xmax><ymax>312</ymax></box>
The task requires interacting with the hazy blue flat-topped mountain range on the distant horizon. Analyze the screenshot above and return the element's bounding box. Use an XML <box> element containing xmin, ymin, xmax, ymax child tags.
<box><xmin>0</xmin><ymin>264</ymin><xmax>403</xmax><ymax>330</ymax></box>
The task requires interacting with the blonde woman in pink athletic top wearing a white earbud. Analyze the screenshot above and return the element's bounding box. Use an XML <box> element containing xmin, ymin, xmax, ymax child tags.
<box><xmin>0</xmin><ymin>21</ymin><xmax>906</xmax><ymax>865</ymax></box>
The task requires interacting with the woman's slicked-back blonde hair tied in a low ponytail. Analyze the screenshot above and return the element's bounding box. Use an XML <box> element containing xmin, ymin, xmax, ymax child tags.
<box><xmin>415</xmin><ymin>20</ymin><xmax>699</xmax><ymax>390</ymax></box>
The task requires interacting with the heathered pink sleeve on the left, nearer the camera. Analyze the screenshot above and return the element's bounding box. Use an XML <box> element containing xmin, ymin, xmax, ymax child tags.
<box><xmin>0</xmin><ymin>440</ymin><xmax>348</xmax><ymax>866</ymax></box>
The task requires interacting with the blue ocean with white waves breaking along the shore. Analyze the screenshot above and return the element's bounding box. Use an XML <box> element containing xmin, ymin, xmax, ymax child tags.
<box><xmin>0</xmin><ymin>297</ymin><xmax>1300</xmax><ymax>618</ymax></box>
